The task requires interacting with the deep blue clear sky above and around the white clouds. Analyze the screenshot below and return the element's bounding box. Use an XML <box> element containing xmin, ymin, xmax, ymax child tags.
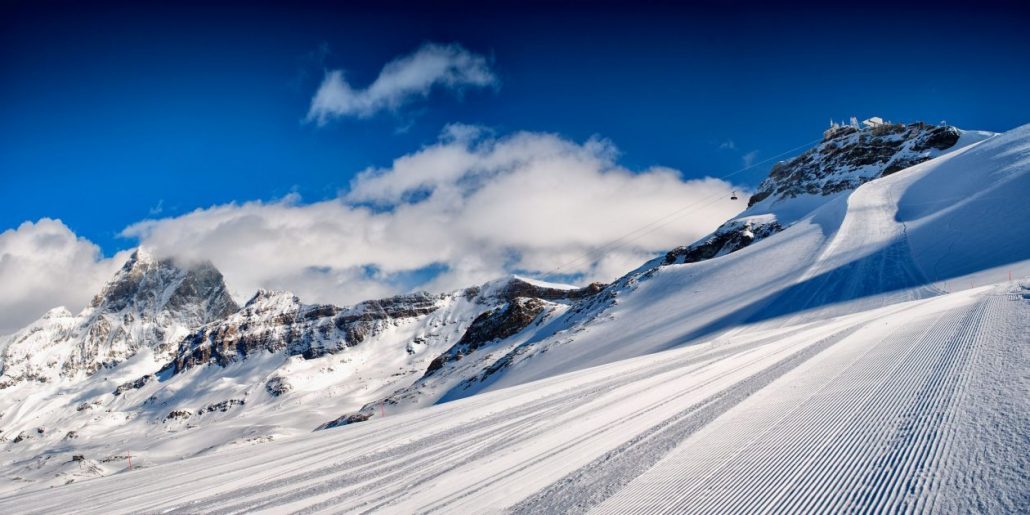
<box><xmin>0</xmin><ymin>1</ymin><xmax>1030</xmax><ymax>254</ymax></box>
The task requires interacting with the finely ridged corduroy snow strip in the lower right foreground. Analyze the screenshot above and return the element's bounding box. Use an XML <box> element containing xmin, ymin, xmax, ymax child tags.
<box><xmin>598</xmin><ymin>297</ymin><xmax>1005</xmax><ymax>513</ymax></box>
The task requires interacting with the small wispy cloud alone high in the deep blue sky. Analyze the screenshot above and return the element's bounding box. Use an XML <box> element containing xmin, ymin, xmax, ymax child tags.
<box><xmin>307</xmin><ymin>43</ymin><xmax>499</xmax><ymax>125</ymax></box>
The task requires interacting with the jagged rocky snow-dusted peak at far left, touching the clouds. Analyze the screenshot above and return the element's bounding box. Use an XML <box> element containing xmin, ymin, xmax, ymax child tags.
<box><xmin>0</xmin><ymin>249</ymin><xmax>238</xmax><ymax>385</ymax></box>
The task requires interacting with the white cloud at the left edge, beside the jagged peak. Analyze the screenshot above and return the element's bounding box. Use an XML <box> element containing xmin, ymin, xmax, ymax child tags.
<box><xmin>0</xmin><ymin>218</ymin><xmax>128</xmax><ymax>334</ymax></box>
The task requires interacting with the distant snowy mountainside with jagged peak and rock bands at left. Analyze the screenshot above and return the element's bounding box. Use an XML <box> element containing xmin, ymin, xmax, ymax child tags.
<box><xmin>0</xmin><ymin>269</ymin><xmax>600</xmax><ymax>491</ymax></box>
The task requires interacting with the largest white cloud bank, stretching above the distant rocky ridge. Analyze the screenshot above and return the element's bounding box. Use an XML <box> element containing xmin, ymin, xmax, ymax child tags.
<box><xmin>123</xmin><ymin>126</ymin><xmax>735</xmax><ymax>304</ymax></box>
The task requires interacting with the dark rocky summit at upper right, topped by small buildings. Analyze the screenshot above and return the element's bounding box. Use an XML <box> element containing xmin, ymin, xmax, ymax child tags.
<box><xmin>748</xmin><ymin>123</ymin><xmax>961</xmax><ymax>207</ymax></box>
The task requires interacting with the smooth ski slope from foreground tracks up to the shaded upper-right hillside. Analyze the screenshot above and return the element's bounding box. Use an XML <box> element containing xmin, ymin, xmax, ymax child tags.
<box><xmin>0</xmin><ymin>126</ymin><xmax>1030</xmax><ymax>514</ymax></box>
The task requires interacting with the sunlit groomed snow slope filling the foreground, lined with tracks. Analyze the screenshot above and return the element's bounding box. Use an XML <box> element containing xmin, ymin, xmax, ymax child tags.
<box><xmin>0</xmin><ymin>282</ymin><xmax>1030</xmax><ymax>513</ymax></box>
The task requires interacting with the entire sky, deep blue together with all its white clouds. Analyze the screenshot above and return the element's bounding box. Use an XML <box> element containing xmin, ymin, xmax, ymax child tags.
<box><xmin>0</xmin><ymin>0</ymin><xmax>1030</xmax><ymax>334</ymax></box>
